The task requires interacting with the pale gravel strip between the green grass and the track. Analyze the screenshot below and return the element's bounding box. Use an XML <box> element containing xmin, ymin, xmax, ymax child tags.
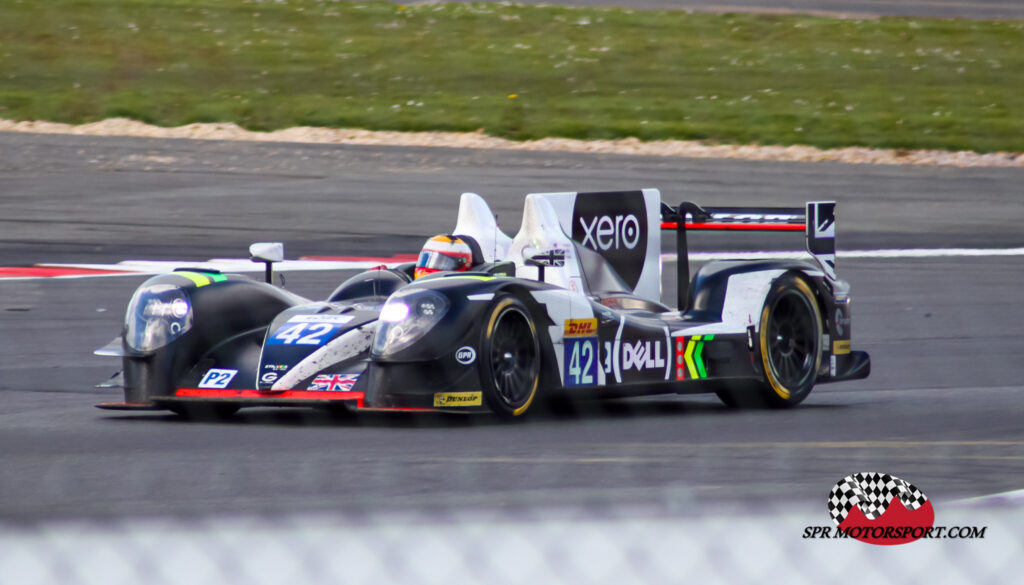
<box><xmin>0</xmin><ymin>118</ymin><xmax>1024</xmax><ymax>167</ymax></box>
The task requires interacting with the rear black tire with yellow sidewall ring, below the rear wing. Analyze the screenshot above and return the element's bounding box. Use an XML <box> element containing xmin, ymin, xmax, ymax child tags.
<box><xmin>718</xmin><ymin>275</ymin><xmax>822</xmax><ymax>408</ymax></box>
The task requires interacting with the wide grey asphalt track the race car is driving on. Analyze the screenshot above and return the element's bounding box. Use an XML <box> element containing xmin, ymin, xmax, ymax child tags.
<box><xmin>0</xmin><ymin>134</ymin><xmax>1024</xmax><ymax>524</ymax></box>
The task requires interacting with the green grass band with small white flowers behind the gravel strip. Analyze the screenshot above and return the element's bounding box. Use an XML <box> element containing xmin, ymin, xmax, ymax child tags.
<box><xmin>0</xmin><ymin>0</ymin><xmax>1024</xmax><ymax>152</ymax></box>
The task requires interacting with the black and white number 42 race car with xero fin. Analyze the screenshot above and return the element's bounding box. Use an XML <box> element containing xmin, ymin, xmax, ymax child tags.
<box><xmin>96</xmin><ymin>190</ymin><xmax>870</xmax><ymax>418</ymax></box>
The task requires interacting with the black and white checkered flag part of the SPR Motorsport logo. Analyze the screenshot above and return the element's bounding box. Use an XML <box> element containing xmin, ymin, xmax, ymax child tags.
<box><xmin>828</xmin><ymin>473</ymin><xmax>928</xmax><ymax>526</ymax></box>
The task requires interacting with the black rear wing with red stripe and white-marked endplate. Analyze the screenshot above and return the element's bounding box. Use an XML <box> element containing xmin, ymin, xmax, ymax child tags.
<box><xmin>662</xmin><ymin>201</ymin><xmax>836</xmax><ymax>310</ymax></box>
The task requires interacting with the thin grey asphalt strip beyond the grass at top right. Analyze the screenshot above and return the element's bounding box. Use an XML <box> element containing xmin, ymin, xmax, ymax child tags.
<box><xmin>424</xmin><ymin>0</ymin><xmax>1024</xmax><ymax>19</ymax></box>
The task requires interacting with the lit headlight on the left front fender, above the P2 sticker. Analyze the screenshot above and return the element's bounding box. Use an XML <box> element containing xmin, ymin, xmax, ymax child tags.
<box><xmin>125</xmin><ymin>284</ymin><xmax>193</xmax><ymax>351</ymax></box>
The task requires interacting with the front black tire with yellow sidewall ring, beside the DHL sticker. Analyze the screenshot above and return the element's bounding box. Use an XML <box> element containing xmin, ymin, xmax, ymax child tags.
<box><xmin>479</xmin><ymin>296</ymin><xmax>541</xmax><ymax>418</ymax></box>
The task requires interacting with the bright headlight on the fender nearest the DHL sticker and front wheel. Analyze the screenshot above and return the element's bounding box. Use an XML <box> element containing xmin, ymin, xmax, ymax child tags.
<box><xmin>373</xmin><ymin>289</ymin><xmax>451</xmax><ymax>358</ymax></box>
